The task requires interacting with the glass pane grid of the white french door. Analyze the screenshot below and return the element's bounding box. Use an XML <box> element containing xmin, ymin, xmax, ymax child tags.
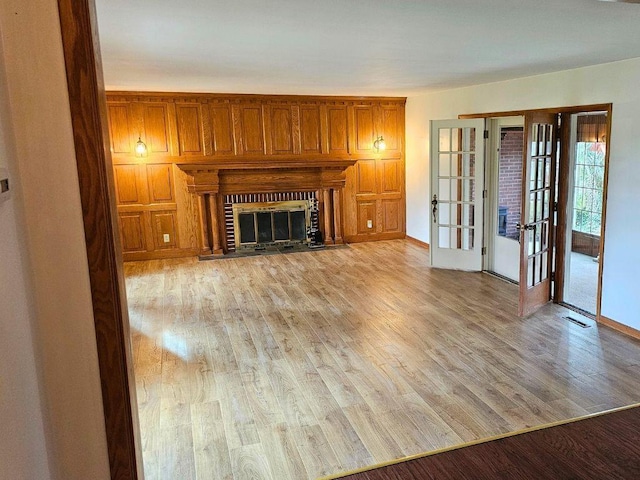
<box><xmin>436</xmin><ymin>127</ymin><xmax>476</xmax><ymax>250</ymax></box>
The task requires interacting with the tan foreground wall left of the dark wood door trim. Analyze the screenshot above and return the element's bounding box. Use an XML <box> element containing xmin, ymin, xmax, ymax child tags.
<box><xmin>0</xmin><ymin>0</ymin><xmax>110</xmax><ymax>480</ymax></box>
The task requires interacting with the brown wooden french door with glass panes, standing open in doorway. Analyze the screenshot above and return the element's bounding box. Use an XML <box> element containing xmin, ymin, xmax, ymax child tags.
<box><xmin>518</xmin><ymin>113</ymin><xmax>557</xmax><ymax>316</ymax></box>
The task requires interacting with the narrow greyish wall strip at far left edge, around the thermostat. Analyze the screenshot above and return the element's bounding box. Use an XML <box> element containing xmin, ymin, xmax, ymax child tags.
<box><xmin>0</xmin><ymin>31</ymin><xmax>49</xmax><ymax>480</ymax></box>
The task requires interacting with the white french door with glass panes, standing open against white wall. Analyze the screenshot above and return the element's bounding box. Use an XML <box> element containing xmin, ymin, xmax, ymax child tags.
<box><xmin>430</xmin><ymin>119</ymin><xmax>484</xmax><ymax>271</ymax></box>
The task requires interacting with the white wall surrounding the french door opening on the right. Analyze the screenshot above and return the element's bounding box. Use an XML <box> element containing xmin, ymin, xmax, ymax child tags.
<box><xmin>406</xmin><ymin>59</ymin><xmax>640</xmax><ymax>329</ymax></box>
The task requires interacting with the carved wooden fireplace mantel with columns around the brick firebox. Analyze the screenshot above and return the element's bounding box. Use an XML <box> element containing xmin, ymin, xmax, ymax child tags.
<box><xmin>178</xmin><ymin>158</ymin><xmax>356</xmax><ymax>255</ymax></box>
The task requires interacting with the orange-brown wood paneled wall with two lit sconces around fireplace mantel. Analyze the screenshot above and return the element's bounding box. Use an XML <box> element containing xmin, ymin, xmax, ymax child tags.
<box><xmin>107</xmin><ymin>92</ymin><xmax>405</xmax><ymax>260</ymax></box>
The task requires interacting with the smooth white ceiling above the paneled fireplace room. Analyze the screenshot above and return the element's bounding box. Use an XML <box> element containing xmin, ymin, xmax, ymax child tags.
<box><xmin>96</xmin><ymin>0</ymin><xmax>640</xmax><ymax>95</ymax></box>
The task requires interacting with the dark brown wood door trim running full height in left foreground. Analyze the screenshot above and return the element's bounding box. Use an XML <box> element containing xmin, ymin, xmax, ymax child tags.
<box><xmin>58</xmin><ymin>0</ymin><xmax>143</xmax><ymax>480</ymax></box>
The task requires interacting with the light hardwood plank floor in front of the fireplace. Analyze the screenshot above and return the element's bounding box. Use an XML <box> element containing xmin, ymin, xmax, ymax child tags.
<box><xmin>125</xmin><ymin>240</ymin><xmax>640</xmax><ymax>480</ymax></box>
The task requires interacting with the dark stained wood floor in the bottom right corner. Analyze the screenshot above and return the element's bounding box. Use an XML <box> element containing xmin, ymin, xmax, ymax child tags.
<box><xmin>332</xmin><ymin>407</ymin><xmax>640</xmax><ymax>480</ymax></box>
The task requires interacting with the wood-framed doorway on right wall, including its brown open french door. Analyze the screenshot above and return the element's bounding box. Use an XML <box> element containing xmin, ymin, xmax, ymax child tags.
<box><xmin>468</xmin><ymin>104</ymin><xmax>611</xmax><ymax>319</ymax></box>
